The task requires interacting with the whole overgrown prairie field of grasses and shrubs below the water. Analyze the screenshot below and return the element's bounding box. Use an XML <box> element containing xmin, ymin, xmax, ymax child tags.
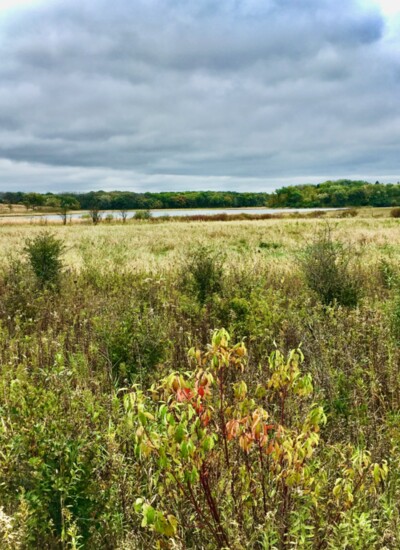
<box><xmin>0</xmin><ymin>215</ymin><xmax>400</xmax><ymax>550</ymax></box>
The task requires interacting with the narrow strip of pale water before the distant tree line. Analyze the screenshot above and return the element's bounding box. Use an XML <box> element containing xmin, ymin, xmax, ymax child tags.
<box><xmin>8</xmin><ymin>208</ymin><xmax>340</xmax><ymax>221</ymax></box>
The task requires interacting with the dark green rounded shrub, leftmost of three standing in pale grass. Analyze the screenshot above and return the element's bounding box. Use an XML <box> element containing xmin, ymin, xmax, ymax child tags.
<box><xmin>24</xmin><ymin>231</ymin><xmax>64</xmax><ymax>287</ymax></box>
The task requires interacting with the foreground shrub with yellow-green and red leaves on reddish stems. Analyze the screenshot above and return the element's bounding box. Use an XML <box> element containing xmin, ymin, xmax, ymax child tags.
<box><xmin>124</xmin><ymin>329</ymin><xmax>388</xmax><ymax>550</ymax></box>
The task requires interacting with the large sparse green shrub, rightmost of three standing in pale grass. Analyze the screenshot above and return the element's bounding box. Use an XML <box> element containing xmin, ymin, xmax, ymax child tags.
<box><xmin>300</xmin><ymin>227</ymin><xmax>361</xmax><ymax>307</ymax></box>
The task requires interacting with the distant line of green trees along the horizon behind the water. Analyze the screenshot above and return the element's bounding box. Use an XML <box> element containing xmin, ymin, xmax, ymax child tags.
<box><xmin>0</xmin><ymin>179</ymin><xmax>400</xmax><ymax>215</ymax></box>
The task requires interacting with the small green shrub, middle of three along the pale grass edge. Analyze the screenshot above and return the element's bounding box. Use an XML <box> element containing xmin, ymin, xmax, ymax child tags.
<box><xmin>183</xmin><ymin>246</ymin><xmax>223</xmax><ymax>304</ymax></box>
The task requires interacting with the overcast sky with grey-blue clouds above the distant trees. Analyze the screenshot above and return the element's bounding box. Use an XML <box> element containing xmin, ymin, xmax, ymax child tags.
<box><xmin>0</xmin><ymin>0</ymin><xmax>400</xmax><ymax>192</ymax></box>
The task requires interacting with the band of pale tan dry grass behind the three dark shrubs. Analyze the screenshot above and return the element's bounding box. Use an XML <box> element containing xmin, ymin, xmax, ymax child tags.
<box><xmin>0</xmin><ymin>217</ymin><xmax>400</xmax><ymax>278</ymax></box>
